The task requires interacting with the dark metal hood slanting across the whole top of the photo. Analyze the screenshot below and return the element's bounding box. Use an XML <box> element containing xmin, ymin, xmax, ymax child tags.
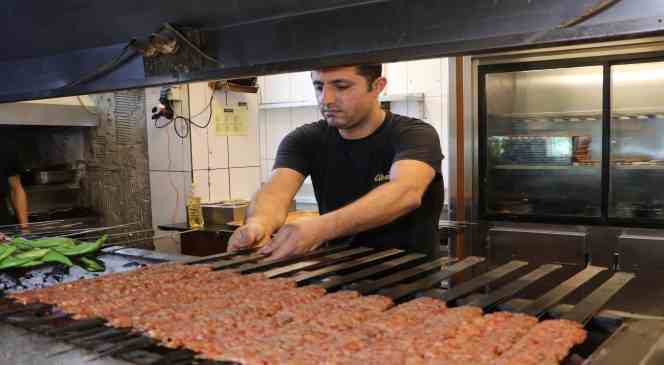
<box><xmin>0</xmin><ymin>0</ymin><xmax>664</xmax><ymax>102</ymax></box>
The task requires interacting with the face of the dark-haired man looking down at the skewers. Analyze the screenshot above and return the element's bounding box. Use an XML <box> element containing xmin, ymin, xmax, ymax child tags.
<box><xmin>311</xmin><ymin>67</ymin><xmax>383</xmax><ymax>129</ymax></box>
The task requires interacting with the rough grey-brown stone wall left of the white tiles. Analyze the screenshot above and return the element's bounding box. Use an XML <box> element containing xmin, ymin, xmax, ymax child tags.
<box><xmin>83</xmin><ymin>89</ymin><xmax>152</xmax><ymax>229</ymax></box>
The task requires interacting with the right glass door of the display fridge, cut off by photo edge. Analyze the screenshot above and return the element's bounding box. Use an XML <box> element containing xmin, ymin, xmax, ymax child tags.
<box><xmin>608</xmin><ymin>62</ymin><xmax>664</xmax><ymax>221</ymax></box>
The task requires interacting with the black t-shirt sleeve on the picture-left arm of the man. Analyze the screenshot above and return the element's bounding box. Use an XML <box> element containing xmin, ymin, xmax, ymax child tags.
<box><xmin>274</xmin><ymin>125</ymin><xmax>315</xmax><ymax>177</ymax></box>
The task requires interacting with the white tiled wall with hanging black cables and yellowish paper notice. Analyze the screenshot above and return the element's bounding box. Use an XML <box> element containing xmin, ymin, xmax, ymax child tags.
<box><xmin>145</xmin><ymin>82</ymin><xmax>260</xmax><ymax>252</ymax></box>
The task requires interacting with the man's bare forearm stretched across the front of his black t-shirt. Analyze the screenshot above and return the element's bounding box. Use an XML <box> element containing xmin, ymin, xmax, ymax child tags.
<box><xmin>319</xmin><ymin>182</ymin><xmax>422</xmax><ymax>240</ymax></box>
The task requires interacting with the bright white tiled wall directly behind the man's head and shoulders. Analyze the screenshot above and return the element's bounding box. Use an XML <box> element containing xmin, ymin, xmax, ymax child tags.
<box><xmin>258</xmin><ymin>58</ymin><xmax>449</xmax><ymax>202</ymax></box>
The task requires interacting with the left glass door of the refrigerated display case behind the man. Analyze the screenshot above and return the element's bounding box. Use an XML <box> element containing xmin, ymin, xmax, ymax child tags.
<box><xmin>480</xmin><ymin>66</ymin><xmax>603</xmax><ymax>217</ymax></box>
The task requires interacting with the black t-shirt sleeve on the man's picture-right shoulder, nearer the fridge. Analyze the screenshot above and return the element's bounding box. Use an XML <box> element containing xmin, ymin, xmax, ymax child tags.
<box><xmin>394</xmin><ymin>119</ymin><xmax>443</xmax><ymax>174</ymax></box>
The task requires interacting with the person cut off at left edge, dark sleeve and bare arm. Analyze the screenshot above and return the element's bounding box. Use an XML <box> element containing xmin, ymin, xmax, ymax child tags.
<box><xmin>0</xmin><ymin>141</ymin><xmax>28</xmax><ymax>240</ymax></box>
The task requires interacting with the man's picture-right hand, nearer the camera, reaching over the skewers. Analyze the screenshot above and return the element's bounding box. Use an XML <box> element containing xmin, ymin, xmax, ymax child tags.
<box><xmin>260</xmin><ymin>217</ymin><xmax>325</xmax><ymax>260</ymax></box>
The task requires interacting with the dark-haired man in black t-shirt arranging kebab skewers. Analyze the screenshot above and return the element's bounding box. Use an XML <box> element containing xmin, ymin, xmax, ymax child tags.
<box><xmin>229</xmin><ymin>65</ymin><xmax>443</xmax><ymax>259</ymax></box>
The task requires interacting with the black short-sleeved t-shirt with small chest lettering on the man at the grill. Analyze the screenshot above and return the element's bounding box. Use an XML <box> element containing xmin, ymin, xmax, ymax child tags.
<box><xmin>274</xmin><ymin>112</ymin><xmax>443</xmax><ymax>256</ymax></box>
